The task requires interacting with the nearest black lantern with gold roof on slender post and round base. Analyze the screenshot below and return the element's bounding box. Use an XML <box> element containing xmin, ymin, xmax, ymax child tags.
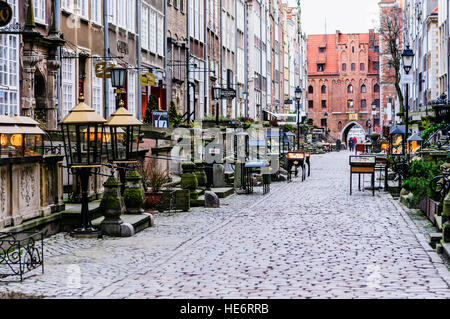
<box><xmin>60</xmin><ymin>96</ymin><xmax>106</xmax><ymax>236</ymax></box>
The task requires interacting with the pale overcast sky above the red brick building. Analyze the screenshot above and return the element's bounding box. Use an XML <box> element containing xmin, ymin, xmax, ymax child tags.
<box><xmin>291</xmin><ymin>0</ymin><xmax>379</xmax><ymax>34</ymax></box>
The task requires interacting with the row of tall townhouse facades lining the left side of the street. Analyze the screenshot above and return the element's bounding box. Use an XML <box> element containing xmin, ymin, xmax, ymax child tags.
<box><xmin>0</xmin><ymin>0</ymin><xmax>307</xmax><ymax>130</ymax></box>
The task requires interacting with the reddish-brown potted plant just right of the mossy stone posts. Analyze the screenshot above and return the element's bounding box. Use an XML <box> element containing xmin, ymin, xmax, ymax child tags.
<box><xmin>142</xmin><ymin>158</ymin><xmax>168</xmax><ymax>209</ymax></box>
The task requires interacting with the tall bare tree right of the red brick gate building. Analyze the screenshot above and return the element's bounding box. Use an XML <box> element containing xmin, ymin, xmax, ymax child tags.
<box><xmin>380</xmin><ymin>5</ymin><xmax>405</xmax><ymax>119</ymax></box>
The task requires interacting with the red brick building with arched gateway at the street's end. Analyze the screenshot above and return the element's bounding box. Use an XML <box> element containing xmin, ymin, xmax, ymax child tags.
<box><xmin>308</xmin><ymin>30</ymin><xmax>380</xmax><ymax>141</ymax></box>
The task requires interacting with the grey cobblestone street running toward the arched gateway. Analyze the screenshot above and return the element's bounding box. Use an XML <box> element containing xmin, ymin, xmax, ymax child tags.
<box><xmin>0</xmin><ymin>151</ymin><xmax>450</xmax><ymax>298</ymax></box>
